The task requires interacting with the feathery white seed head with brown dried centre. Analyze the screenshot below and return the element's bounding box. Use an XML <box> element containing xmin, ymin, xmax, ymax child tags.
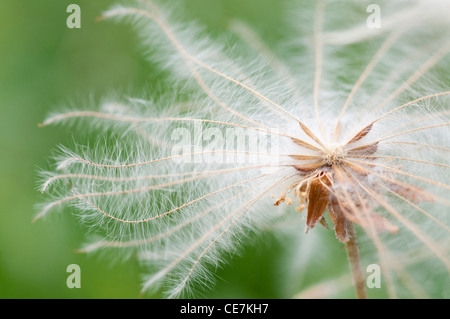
<box><xmin>36</xmin><ymin>0</ymin><xmax>450</xmax><ymax>298</ymax></box>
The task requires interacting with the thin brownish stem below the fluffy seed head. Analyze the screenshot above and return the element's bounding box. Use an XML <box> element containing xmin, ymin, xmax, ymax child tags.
<box><xmin>345</xmin><ymin>222</ymin><xmax>367</xmax><ymax>299</ymax></box>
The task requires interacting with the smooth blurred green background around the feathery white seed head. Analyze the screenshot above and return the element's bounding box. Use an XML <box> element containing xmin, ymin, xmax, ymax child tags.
<box><xmin>0</xmin><ymin>0</ymin><xmax>362</xmax><ymax>298</ymax></box>
